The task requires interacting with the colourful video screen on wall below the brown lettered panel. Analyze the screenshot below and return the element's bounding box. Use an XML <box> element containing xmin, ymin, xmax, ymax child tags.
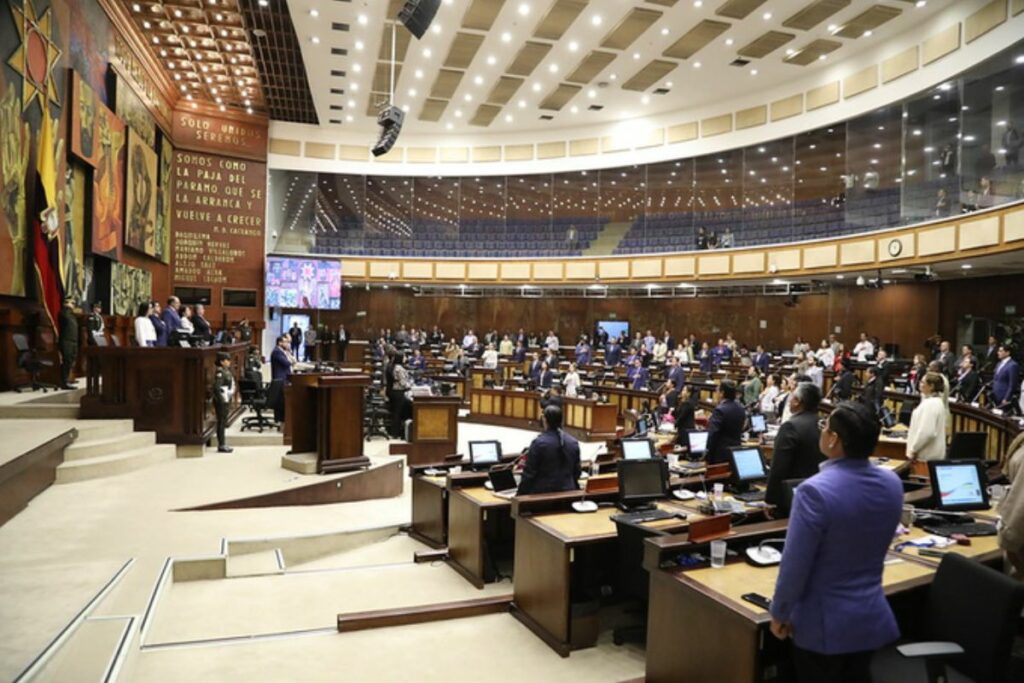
<box><xmin>266</xmin><ymin>256</ymin><xmax>341</xmax><ymax>310</ymax></box>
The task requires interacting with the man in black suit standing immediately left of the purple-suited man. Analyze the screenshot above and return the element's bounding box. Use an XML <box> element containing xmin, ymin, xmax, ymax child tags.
<box><xmin>765</xmin><ymin>382</ymin><xmax>825</xmax><ymax>514</ymax></box>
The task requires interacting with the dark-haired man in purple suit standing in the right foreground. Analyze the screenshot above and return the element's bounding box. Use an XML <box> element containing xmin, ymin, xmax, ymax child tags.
<box><xmin>771</xmin><ymin>403</ymin><xmax>903</xmax><ymax>683</ymax></box>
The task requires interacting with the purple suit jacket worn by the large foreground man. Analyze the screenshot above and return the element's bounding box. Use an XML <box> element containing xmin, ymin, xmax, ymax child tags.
<box><xmin>771</xmin><ymin>458</ymin><xmax>903</xmax><ymax>654</ymax></box>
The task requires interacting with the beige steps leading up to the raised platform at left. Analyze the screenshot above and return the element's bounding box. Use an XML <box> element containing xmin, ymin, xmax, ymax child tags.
<box><xmin>55</xmin><ymin>420</ymin><xmax>176</xmax><ymax>484</ymax></box>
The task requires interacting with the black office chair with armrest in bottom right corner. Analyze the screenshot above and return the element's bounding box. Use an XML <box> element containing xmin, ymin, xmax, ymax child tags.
<box><xmin>871</xmin><ymin>553</ymin><xmax>1024</xmax><ymax>683</ymax></box>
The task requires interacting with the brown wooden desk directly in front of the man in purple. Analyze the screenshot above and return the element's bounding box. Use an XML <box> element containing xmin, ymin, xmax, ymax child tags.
<box><xmin>646</xmin><ymin>554</ymin><xmax>935</xmax><ymax>683</ymax></box>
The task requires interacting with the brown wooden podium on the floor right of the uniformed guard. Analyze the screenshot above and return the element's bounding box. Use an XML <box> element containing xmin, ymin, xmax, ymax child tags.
<box><xmin>319</xmin><ymin>375</ymin><xmax>370</xmax><ymax>473</ymax></box>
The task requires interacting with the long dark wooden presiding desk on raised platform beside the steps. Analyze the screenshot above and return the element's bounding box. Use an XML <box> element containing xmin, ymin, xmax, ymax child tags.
<box><xmin>81</xmin><ymin>344</ymin><xmax>249</xmax><ymax>447</ymax></box>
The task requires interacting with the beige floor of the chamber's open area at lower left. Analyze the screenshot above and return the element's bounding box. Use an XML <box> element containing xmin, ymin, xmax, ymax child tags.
<box><xmin>0</xmin><ymin>409</ymin><xmax>643</xmax><ymax>682</ymax></box>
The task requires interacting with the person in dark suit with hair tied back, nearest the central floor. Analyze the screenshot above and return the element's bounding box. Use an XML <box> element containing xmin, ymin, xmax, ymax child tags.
<box><xmin>518</xmin><ymin>405</ymin><xmax>580</xmax><ymax>496</ymax></box>
